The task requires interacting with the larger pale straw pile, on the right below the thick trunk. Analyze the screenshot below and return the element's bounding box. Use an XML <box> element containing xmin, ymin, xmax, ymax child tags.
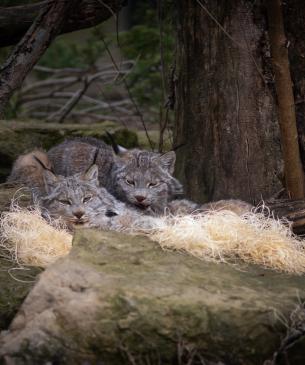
<box><xmin>150</xmin><ymin>211</ymin><xmax>305</xmax><ymax>274</ymax></box>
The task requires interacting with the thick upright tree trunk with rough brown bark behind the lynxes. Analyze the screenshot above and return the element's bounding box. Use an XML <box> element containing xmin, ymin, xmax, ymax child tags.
<box><xmin>174</xmin><ymin>0</ymin><xmax>283</xmax><ymax>202</ymax></box>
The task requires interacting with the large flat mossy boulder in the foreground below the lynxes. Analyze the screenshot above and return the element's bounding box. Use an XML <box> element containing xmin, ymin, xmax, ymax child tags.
<box><xmin>0</xmin><ymin>230</ymin><xmax>305</xmax><ymax>365</ymax></box>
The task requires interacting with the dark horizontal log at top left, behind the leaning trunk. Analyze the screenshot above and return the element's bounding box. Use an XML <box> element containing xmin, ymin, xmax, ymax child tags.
<box><xmin>0</xmin><ymin>0</ymin><xmax>125</xmax><ymax>47</ymax></box>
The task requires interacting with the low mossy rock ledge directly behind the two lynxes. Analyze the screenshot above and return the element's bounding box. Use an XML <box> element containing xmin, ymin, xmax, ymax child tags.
<box><xmin>0</xmin><ymin>121</ymin><xmax>139</xmax><ymax>182</ymax></box>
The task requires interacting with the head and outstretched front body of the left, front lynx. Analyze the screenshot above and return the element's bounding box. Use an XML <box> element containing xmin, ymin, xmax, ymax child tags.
<box><xmin>40</xmin><ymin>165</ymin><xmax>154</xmax><ymax>232</ymax></box>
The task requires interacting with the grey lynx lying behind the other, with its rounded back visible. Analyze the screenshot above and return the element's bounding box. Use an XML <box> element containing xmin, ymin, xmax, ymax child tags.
<box><xmin>48</xmin><ymin>138</ymin><xmax>183</xmax><ymax>214</ymax></box>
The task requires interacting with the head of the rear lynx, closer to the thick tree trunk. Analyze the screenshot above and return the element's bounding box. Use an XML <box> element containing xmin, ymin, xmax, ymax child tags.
<box><xmin>113</xmin><ymin>150</ymin><xmax>183</xmax><ymax>213</ymax></box>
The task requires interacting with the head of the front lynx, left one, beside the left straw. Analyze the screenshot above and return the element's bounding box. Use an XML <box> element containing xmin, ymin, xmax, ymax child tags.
<box><xmin>40</xmin><ymin>165</ymin><xmax>117</xmax><ymax>229</ymax></box>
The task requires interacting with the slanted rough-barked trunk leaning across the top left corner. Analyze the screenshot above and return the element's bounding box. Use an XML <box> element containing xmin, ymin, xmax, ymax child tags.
<box><xmin>0</xmin><ymin>0</ymin><xmax>77</xmax><ymax>117</ymax></box>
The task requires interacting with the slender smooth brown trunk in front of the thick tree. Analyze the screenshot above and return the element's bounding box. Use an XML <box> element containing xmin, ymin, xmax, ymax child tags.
<box><xmin>267</xmin><ymin>0</ymin><xmax>304</xmax><ymax>199</ymax></box>
